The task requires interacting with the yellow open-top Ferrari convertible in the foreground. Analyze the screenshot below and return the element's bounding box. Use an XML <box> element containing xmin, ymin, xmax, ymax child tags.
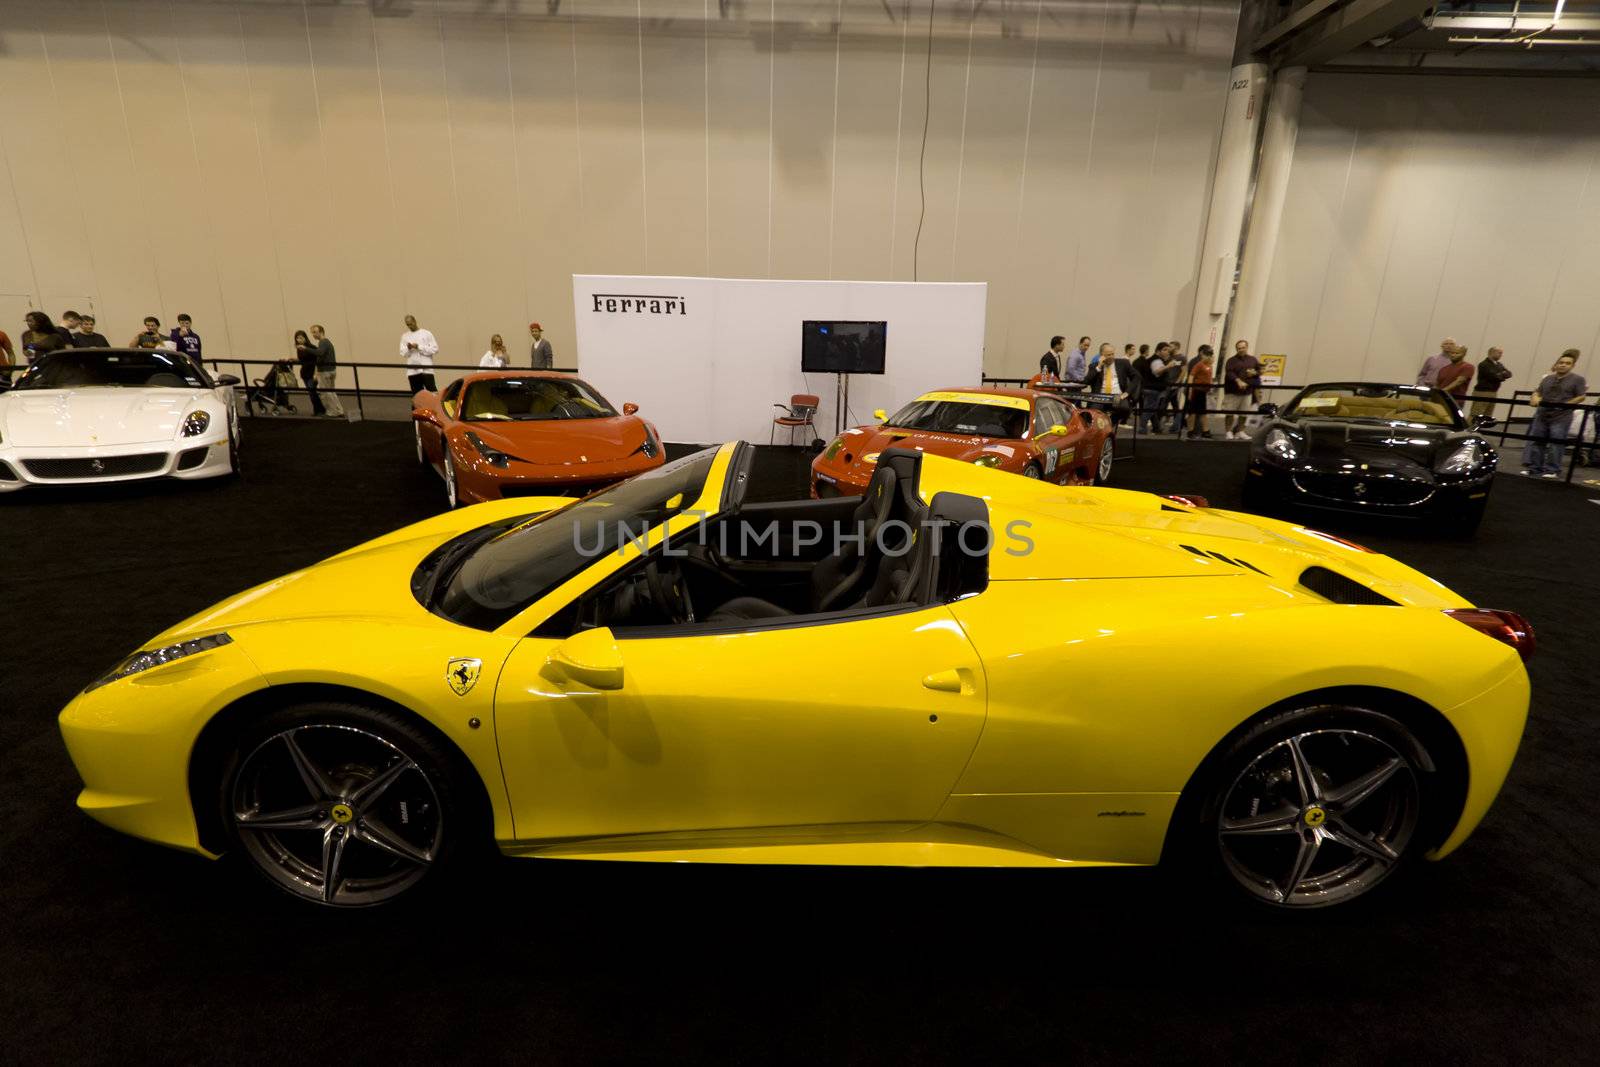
<box><xmin>61</xmin><ymin>443</ymin><xmax>1533</xmax><ymax>907</ymax></box>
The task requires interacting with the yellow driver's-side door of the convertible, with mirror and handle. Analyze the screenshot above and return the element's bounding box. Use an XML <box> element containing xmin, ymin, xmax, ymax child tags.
<box><xmin>494</xmin><ymin>606</ymin><xmax>986</xmax><ymax>841</ymax></box>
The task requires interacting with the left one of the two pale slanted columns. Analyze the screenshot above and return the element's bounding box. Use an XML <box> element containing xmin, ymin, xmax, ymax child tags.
<box><xmin>1189</xmin><ymin>62</ymin><xmax>1267</xmax><ymax>357</ymax></box>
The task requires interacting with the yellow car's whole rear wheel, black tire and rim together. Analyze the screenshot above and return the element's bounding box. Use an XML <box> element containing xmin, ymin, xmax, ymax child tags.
<box><xmin>1173</xmin><ymin>704</ymin><xmax>1438</xmax><ymax>910</ymax></box>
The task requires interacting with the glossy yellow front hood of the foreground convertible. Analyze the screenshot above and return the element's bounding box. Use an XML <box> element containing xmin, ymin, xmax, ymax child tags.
<box><xmin>147</xmin><ymin>496</ymin><xmax>571</xmax><ymax>646</ymax></box>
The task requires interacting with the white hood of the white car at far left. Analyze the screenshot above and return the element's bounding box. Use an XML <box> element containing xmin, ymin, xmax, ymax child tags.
<box><xmin>0</xmin><ymin>387</ymin><xmax>212</xmax><ymax>448</ymax></box>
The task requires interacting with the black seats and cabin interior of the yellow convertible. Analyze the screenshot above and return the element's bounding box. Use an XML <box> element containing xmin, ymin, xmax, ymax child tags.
<box><xmin>538</xmin><ymin>450</ymin><xmax>989</xmax><ymax>637</ymax></box>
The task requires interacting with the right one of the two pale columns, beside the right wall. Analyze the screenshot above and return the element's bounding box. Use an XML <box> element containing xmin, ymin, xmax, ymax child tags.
<box><xmin>1226</xmin><ymin>67</ymin><xmax>1306</xmax><ymax>358</ymax></box>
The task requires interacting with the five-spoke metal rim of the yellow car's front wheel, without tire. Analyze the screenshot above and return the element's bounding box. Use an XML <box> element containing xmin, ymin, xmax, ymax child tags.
<box><xmin>227</xmin><ymin>723</ymin><xmax>445</xmax><ymax>905</ymax></box>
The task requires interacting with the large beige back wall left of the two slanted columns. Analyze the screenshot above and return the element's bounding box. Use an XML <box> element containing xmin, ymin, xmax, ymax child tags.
<box><xmin>0</xmin><ymin>0</ymin><xmax>1235</xmax><ymax>384</ymax></box>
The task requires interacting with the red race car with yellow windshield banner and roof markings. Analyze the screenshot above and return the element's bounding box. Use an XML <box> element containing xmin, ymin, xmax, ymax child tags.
<box><xmin>811</xmin><ymin>387</ymin><xmax>1115</xmax><ymax>498</ymax></box>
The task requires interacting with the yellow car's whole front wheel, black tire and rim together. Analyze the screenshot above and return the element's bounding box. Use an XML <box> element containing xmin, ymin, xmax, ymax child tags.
<box><xmin>216</xmin><ymin>701</ymin><xmax>473</xmax><ymax>907</ymax></box>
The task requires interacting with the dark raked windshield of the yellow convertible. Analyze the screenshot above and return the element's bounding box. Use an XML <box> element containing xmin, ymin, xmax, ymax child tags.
<box><xmin>432</xmin><ymin>448</ymin><xmax>717</xmax><ymax>630</ymax></box>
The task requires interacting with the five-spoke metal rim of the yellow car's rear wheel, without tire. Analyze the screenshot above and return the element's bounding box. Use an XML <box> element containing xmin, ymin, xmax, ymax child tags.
<box><xmin>1216</xmin><ymin>725</ymin><xmax>1422</xmax><ymax>907</ymax></box>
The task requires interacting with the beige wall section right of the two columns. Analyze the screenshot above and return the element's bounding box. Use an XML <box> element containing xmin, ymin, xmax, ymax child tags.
<box><xmin>1254</xmin><ymin>74</ymin><xmax>1600</xmax><ymax>386</ymax></box>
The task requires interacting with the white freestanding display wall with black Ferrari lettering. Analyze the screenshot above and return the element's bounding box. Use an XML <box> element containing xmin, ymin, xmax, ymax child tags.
<box><xmin>573</xmin><ymin>275</ymin><xmax>989</xmax><ymax>443</ymax></box>
